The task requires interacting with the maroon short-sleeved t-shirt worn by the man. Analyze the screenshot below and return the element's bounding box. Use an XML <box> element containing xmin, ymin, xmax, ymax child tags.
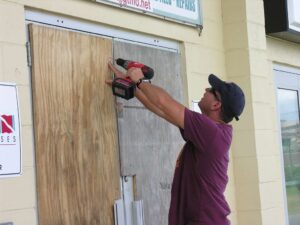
<box><xmin>169</xmin><ymin>108</ymin><xmax>232</xmax><ymax>225</ymax></box>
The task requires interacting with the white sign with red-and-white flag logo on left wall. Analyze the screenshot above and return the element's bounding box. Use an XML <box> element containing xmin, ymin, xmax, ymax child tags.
<box><xmin>0</xmin><ymin>83</ymin><xmax>21</xmax><ymax>177</ymax></box>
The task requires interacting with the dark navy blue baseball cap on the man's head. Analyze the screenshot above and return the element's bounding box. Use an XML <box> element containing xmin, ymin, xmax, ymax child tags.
<box><xmin>208</xmin><ymin>74</ymin><xmax>245</xmax><ymax>120</ymax></box>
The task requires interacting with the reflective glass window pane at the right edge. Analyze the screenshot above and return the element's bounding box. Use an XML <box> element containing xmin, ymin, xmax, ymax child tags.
<box><xmin>278</xmin><ymin>89</ymin><xmax>300</xmax><ymax>225</ymax></box>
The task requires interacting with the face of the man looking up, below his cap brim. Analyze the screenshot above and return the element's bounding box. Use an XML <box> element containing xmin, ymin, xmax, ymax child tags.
<box><xmin>198</xmin><ymin>88</ymin><xmax>221</xmax><ymax>114</ymax></box>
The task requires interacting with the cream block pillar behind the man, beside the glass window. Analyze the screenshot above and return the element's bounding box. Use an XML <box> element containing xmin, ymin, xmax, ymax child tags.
<box><xmin>223</xmin><ymin>0</ymin><xmax>286</xmax><ymax>225</ymax></box>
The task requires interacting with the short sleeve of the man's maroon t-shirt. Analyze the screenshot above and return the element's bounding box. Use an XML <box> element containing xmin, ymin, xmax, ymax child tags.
<box><xmin>182</xmin><ymin>108</ymin><xmax>218</xmax><ymax>151</ymax></box>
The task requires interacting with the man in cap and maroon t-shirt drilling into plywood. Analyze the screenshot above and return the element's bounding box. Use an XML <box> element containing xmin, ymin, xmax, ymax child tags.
<box><xmin>107</xmin><ymin>63</ymin><xmax>245</xmax><ymax>225</ymax></box>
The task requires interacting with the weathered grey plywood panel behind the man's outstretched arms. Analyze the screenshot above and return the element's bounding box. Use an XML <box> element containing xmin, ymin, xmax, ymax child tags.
<box><xmin>114</xmin><ymin>42</ymin><xmax>183</xmax><ymax>225</ymax></box>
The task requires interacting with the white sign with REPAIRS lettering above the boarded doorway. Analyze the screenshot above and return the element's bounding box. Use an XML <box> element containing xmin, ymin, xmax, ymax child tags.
<box><xmin>96</xmin><ymin>0</ymin><xmax>202</xmax><ymax>27</ymax></box>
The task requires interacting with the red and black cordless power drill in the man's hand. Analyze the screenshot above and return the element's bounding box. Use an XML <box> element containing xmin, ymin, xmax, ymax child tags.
<box><xmin>112</xmin><ymin>58</ymin><xmax>154</xmax><ymax>100</ymax></box>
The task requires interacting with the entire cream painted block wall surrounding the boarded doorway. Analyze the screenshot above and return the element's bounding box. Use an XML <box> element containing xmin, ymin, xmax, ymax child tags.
<box><xmin>0</xmin><ymin>0</ymin><xmax>299</xmax><ymax>225</ymax></box>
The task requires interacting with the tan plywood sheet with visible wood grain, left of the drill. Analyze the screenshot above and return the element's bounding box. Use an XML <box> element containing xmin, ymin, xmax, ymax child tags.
<box><xmin>29</xmin><ymin>24</ymin><xmax>120</xmax><ymax>225</ymax></box>
